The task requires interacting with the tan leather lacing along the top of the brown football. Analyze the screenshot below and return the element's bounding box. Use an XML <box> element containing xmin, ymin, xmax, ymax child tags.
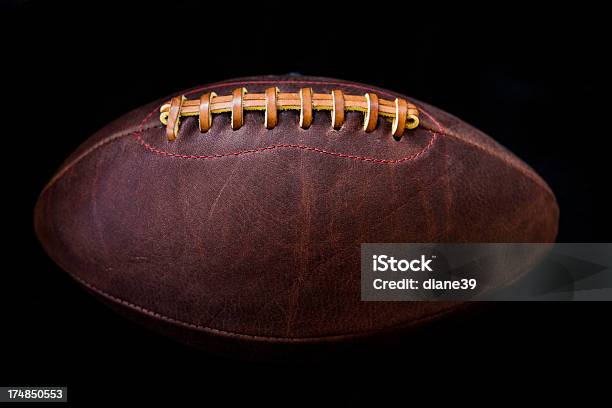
<box><xmin>160</xmin><ymin>87</ymin><xmax>419</xmax><ymax>141</ymax></box>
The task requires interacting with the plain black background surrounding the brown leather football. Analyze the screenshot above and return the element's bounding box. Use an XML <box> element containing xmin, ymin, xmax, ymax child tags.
<box><xmin>0</xmin><ymin>2</ymin><xmax>612</xmax><ymax>405</ymax></box>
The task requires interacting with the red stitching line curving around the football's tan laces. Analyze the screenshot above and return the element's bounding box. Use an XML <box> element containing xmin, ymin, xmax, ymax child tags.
<box><xmin>134</xmin><ymin>81</ymin><xmax>446</xmax><ymax>164</ymax></box>
